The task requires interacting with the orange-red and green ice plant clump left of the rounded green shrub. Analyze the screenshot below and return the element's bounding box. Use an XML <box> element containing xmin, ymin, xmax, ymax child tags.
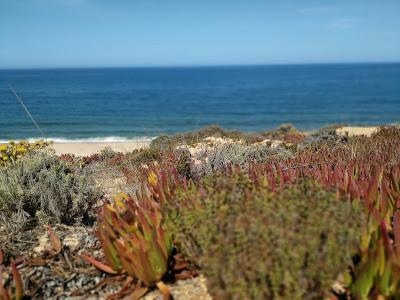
<box><xmin>82</xmin><ymin>193</ymin><xmax>172</xmax><ymax>299</ymax></box>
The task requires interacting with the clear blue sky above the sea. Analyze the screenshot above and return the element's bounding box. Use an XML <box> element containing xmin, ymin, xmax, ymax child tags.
<box><xmin>0</xmin><ymin>0</ymin><xmax>400</xmax><ymax>68</ymax></box>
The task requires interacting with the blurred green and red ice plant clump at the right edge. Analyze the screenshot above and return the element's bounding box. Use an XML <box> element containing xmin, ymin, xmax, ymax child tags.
<box><xmin>351</xmin><ymin>168</ymin><xmax>400</xmax><ymax>299</ymax></box>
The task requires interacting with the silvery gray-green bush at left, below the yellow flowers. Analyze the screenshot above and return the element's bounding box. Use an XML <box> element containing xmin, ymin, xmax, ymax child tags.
<box><xmin>0</xmin><ymin>152</ymin><xmax>100</xmax><ymax>230</ymax></box>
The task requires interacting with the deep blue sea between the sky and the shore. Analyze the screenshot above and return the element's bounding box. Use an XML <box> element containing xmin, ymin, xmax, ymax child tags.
<box><xmin>0</xmin><ymin>64</ymin><xmax>400</xmax><ymax>140</ymax></box>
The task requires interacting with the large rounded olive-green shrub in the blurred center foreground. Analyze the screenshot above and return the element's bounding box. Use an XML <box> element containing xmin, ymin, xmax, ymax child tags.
<box><xmin>167</xmin><ymin>173</ymin><xmax>363</xmax><ymax>299</ymax></box>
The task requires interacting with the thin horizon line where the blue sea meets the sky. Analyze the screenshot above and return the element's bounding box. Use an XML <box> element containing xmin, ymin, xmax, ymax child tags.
<box><xmin>0</xmin><ymin>61</ymin><xmax>400</xmax><ymax>71</ymax></box>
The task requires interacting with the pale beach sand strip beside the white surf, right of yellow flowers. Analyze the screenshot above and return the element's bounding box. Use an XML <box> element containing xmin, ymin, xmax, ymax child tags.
<box><xmin>53</xmin><ymin>141</ymin><xmax>151</xmax><ymax>156</ymax></box>
